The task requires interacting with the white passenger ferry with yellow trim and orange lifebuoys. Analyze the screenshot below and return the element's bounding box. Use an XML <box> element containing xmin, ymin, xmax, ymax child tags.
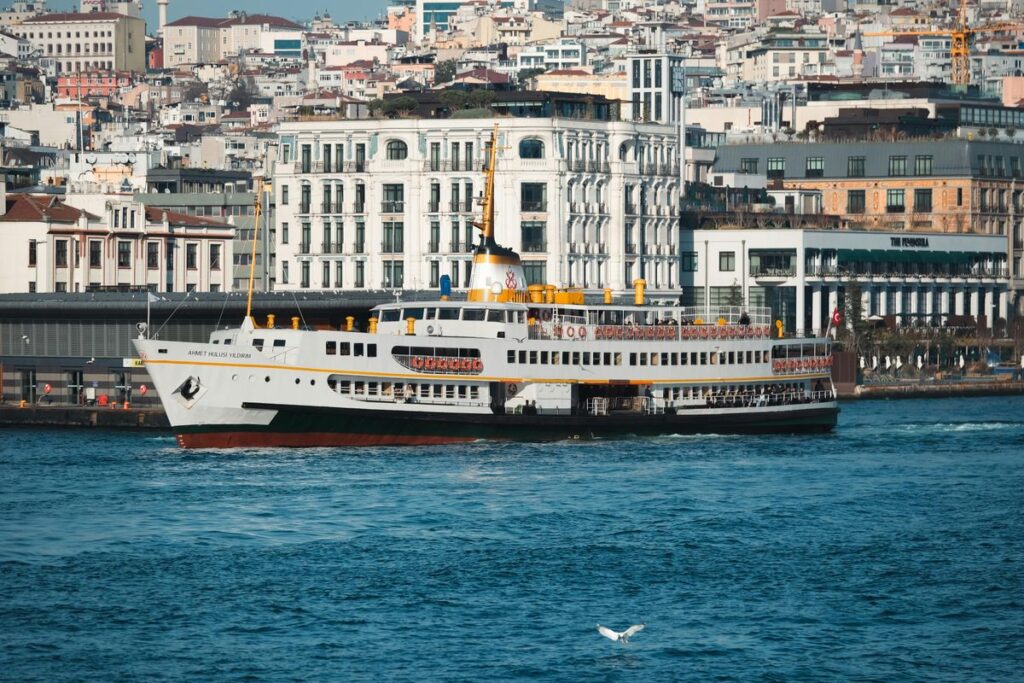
<box><xmin>134</xmin><ymin>130</ymin><xmax>839</xmax><ymax>449</ymax></box>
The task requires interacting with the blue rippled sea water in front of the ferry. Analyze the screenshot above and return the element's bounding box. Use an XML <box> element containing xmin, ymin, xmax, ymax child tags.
<box><xmin>0</xmin><ymin>397</ymin><xmax>1024</xmax><ymax>681</ymax></box>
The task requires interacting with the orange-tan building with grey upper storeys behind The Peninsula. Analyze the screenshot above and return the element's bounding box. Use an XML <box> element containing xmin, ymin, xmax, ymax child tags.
<box><xmin>711</xmin><ymin>138</ymin><xmax>1024</xmax><ymax>317</ymax></box>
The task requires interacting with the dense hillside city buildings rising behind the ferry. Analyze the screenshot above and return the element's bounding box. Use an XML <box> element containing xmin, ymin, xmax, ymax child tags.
<box><xmin>0</xmin><ymin>0</ymin><xmax>1024</xmax><ymax>385</ymax></box>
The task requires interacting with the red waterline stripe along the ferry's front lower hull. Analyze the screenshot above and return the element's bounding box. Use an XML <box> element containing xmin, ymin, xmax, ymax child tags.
<box><xmin>177</xmin><ymin>431</ymin><xmax>476</xmax><ymax>449</ymax></box>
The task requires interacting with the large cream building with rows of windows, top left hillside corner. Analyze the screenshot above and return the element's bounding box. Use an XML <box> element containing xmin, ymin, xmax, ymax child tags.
<box><xmin>10</xmin><ymin>12</ymin><xmax>145</xmax><ymax>74</ymax></box>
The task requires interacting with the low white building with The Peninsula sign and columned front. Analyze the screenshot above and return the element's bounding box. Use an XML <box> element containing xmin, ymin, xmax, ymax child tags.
<box><xmin>681</xmin><ymin>227</ymin><xmax>1013</xmax><ymax>336</ymax></box>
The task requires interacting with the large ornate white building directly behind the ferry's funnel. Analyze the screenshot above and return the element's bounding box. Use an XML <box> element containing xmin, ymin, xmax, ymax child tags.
<box><xmin>274</xmin><ymin>118</ymin><xmax>679</xmax><ymax>291</ymax></box>
